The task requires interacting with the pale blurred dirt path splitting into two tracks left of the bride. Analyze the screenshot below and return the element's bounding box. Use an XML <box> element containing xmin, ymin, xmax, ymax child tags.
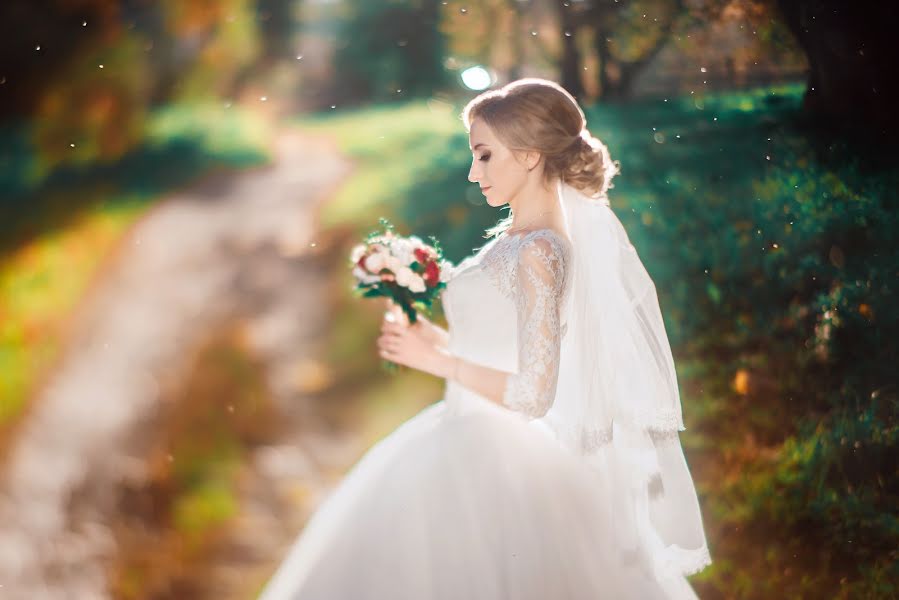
<box><xmin>0</xmin><ymin>133</ymin><xmax>359</xmax><ymax>600</ymax></box>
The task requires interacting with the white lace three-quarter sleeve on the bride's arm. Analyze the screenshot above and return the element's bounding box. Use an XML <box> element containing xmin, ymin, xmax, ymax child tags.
<box><xmin>503</xmin><ymin>238</ymin><xmax>564</xmax><ymax>418</ymax></box>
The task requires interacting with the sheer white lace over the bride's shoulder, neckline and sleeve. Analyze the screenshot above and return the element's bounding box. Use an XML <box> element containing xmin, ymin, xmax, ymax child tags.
<box><xmin>483</xmin><ymin>229</ymin><xmax>570</xmax><ymax>418</ymax></box>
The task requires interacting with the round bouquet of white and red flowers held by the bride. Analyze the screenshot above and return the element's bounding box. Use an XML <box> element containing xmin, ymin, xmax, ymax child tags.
<box><xmin>350</xmin><ymin>219</ymin><xmax>451</xmax><ymax>323</ymax></box>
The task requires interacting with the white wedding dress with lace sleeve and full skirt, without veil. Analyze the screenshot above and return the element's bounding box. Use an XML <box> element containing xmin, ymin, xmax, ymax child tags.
<box><xmin>260</xmin><ymin>229</ymin><xmax>709</xmax><ymax>600</ymax></box>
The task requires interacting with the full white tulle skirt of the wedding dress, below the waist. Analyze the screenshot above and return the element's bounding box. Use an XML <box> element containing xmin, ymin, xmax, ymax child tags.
<box><xmin>260</xmin><ymin>401</ymin><xmax>695</xmax><ymax>600</ymax></box>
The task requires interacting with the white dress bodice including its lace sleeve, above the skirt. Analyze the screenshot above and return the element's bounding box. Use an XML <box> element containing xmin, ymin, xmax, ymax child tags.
<box><xmin>443</xmin><ymin>229</ymin><xmax>571</xmax><ymax>417</ymax></box>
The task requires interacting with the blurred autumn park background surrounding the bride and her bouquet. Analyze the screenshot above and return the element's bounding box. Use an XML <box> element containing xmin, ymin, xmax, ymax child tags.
<box><xmin>0</xmin><ymin>0</ymin><xmax>899</xmax><ymax>599</ymax></box>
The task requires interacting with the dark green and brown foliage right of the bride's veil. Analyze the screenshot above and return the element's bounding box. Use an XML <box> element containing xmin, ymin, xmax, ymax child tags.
<box><xmin>590</xmin><ymin>90</ymin><xmax>899</xmax><ymax>597</ymax></box>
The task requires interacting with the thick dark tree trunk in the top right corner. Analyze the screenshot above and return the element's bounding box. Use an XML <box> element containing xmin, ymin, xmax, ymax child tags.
<box><xmin>778</xmin><ymin>0</ymin><xmax>899</xmax><ymax>135</ymax></box>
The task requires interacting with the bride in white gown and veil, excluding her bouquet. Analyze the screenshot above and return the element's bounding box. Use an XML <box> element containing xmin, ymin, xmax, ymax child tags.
<box><xmin>261</xmin><ymin>79</ymin><xmax>711</xmax><ymax>600</ymax></box>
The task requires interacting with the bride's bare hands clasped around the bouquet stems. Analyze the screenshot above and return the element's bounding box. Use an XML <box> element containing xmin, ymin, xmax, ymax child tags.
<box><xmin>378</xmin><ymin>311</ymin><xmax>454</xmax><ymax>377</ymax></box>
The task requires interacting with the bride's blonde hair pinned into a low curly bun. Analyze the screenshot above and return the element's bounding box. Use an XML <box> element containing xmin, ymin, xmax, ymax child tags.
<box><xmin>462</xmin><ymin>77</ymin><xmax>619</xmax><ymax>235</ymax></box>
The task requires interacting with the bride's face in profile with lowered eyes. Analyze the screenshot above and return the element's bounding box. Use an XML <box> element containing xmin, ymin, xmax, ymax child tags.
<box><xmin>468</xmin><ymin>119</ymin><xmax>528</xmax><ymax>206</ymax></box>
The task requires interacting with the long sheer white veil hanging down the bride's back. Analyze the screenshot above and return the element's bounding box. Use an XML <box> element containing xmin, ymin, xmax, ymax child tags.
<box><xmin>542</xmin><ymin>182</ymin><xmax>711</xmax><ymax>580</ymax></box>
